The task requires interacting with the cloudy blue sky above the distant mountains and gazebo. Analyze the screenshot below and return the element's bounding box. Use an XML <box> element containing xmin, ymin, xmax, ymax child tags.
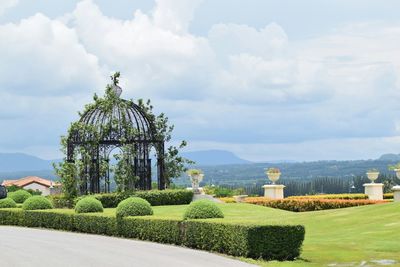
<box><xmin>0</xmin><ymin>0</ymin><xmax>400</xmax><ymax>162</ymax></box>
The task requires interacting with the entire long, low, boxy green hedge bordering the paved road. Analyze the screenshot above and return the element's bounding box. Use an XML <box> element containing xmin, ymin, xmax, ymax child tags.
<box><xmin>0</xmin><ymin>209</ymin><xmax>305</xmax><ymax>260</ymax></box>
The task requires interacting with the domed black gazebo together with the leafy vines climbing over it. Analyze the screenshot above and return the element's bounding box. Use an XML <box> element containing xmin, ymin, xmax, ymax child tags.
<box><xmin>54</xmin><ymin>72</ymin><xmax>193</xmax><ymax>199</ymax></box>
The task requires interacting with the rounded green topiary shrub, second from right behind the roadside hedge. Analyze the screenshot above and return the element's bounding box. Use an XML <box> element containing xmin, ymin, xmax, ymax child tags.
<box><xmin>116</xmin><ymin>197</ymin><xmax>153</xmax><ymax>217</ymax></box>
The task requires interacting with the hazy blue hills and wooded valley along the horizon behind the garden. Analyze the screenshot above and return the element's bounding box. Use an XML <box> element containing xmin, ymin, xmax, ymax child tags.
<box><xmin>0</xmin><ymin>153</ymin><xmax>400</xmax><ymax>186</ymax></box>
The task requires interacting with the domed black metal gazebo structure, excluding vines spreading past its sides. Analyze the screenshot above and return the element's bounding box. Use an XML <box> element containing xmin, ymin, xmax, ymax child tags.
<box><xmin>67</xmin><ymin>75</ymin><xmax>166</xmax><ymax>194</ymax></box>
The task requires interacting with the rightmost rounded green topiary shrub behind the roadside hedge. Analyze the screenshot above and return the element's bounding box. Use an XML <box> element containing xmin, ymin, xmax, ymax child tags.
<box><xmin>183</xmin><ymin>199</ymin><xmax>224</xmax><ymax>220</ymax></box>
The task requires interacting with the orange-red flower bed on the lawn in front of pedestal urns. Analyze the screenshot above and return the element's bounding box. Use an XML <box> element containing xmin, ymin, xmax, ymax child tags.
<box><xmin>245</xmin><ymin>197</ymin><xmax>387</xmax><ymax>212</ymax></box>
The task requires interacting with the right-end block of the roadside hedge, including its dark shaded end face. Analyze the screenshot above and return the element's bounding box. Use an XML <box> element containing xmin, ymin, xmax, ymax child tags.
<box><xmin>184</xmin><ymin>221</ymin><xmax>305</xmax><ymax>260</ymax></box>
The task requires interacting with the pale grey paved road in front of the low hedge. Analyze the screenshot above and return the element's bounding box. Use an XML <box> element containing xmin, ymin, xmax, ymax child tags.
<box><xmin>0</xmin><ymin>226</ymin><xmax>252</xmax><ymax>267</ymax></box>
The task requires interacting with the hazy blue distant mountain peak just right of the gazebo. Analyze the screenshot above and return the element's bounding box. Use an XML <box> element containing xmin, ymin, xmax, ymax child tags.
<box><xmin>182</xmin><ymin>150</ymin><xmax>252</xmax><ymax>165</ymax></box>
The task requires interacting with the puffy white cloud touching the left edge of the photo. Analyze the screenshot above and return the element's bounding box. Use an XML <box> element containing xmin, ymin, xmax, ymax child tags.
<box><xmin>0</xmin><ymin>14</ymin><xmax>102</xmax><ymax>95</ymax></box>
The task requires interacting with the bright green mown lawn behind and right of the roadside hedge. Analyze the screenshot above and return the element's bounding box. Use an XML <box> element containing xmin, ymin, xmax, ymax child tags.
<box><xmin>50</xmin><ymin>203</ymin><xmax>400</xmax><ymax>266</ymax></box>
